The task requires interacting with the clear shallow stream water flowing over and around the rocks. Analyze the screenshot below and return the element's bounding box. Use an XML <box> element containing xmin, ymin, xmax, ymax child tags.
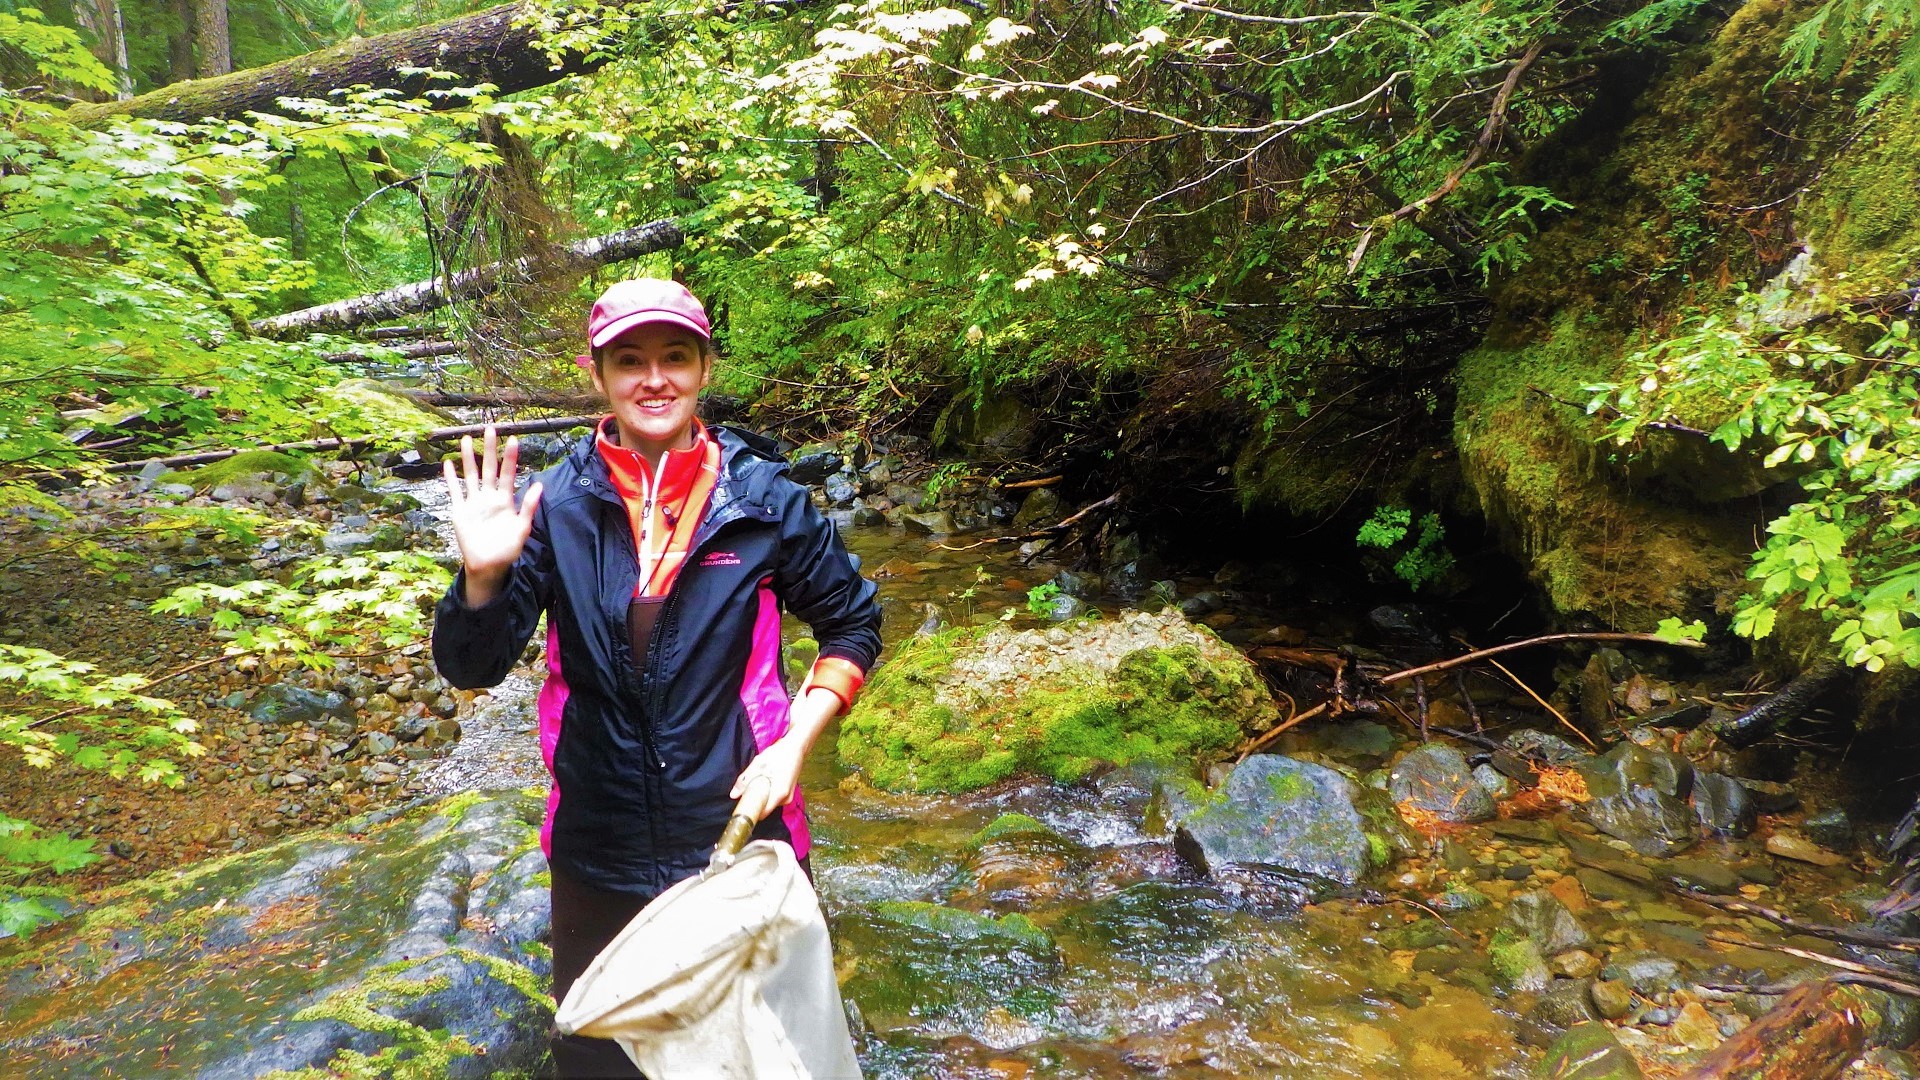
<box><xmin>408</xmin><ymin>484</ymin><xmax>1857</xmax><ymax>1080</ymax></box>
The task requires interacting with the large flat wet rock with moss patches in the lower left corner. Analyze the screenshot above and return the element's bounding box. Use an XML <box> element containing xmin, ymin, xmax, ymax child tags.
<box><xmin>0</xmin><ymin>794</ymin><xmax>551</xmax><ymax>1080</ymax></box>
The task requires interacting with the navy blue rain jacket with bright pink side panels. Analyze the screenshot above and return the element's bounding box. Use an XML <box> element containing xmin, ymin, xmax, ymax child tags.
<box><xmin>434</xmin><ymin>427</ymin><xmax>879</xmax><ymax>894</ymax></box>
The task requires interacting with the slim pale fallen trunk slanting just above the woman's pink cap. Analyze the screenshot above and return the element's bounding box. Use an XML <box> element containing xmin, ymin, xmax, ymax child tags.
<box><xmin>252</xmin><ymin>219</ymin><xmax>684</xmax><ymax>338</ymax></box>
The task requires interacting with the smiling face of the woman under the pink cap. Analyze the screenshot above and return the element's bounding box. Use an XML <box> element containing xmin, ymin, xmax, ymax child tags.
<box><xmin>593</xmin><ymin>323</ymin><xmax>712</xmax><ymax>457</ymax></box>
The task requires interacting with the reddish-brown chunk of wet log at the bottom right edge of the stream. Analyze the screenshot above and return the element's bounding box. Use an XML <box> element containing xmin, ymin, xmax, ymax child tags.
<box><xmin>1684</xmin><ymin>978</ymin><xmax>1880</xmax><ymax>1080</ymax></box>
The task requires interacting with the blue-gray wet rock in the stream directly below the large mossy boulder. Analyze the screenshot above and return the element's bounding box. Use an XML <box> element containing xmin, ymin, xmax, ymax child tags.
<box><xmin>1167</xmin><ymin>753</ymin><xmax>1384</xmax><ymax>886</ymax></box>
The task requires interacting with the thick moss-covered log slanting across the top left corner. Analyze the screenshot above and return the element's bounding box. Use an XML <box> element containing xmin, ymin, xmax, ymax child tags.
<box><xmin>67</xmin><ymin>4</ymin><xmax>591</xmax><ymax>123</ymax></box>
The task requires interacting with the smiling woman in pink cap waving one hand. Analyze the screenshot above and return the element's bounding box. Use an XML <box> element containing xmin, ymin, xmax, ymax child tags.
<box><xmin>434</xmin><ymin>279</ymin><xmax>879</xmax><ymax>1078</ymax></box>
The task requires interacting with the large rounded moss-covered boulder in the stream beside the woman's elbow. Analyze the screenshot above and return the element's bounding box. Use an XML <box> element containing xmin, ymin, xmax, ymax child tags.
<box><xmin>839</xmin><ymin>611</ymin><xmax>1275</xmax><ymax>792</ymax></box>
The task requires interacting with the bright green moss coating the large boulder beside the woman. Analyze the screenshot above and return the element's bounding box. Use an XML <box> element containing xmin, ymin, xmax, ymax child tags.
<box><xmin>839</xmin><ymin>628</ymin><xmax>1273</xmax><ymax>792</ymax></box>
